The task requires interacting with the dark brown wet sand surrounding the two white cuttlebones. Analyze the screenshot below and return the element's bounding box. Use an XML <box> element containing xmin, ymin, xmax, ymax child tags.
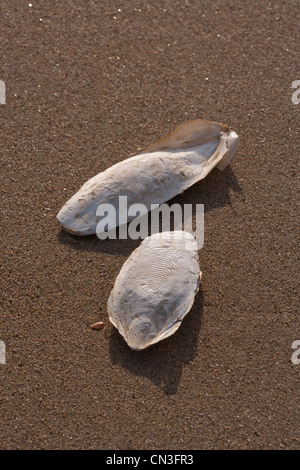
<box><xmin>0</xmin><ymin>0</ymin><xmax>300</xmax><ymax>450</ymax></box>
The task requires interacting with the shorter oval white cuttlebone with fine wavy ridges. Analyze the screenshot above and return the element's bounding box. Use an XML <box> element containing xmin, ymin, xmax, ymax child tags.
<box><xmin>107</xmin><ymin>230</ymin><xmax>202</xmax><ymax>351</ymax></box>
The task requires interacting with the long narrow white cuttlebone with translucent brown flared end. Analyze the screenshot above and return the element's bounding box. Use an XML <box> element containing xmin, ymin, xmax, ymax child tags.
<box><xmin>57</xmin><ymin>119</ymin><xmax>238</xmax><ymax>235</ymax></box>
